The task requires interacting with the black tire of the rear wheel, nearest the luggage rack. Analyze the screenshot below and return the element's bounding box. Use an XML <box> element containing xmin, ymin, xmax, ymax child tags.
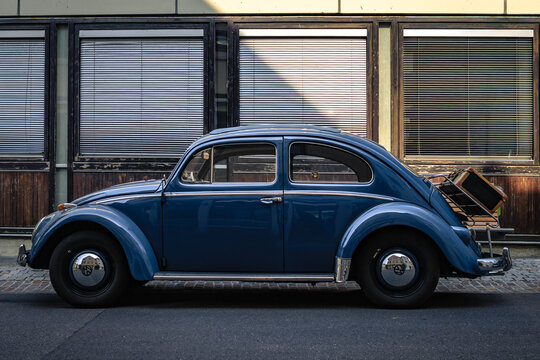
<box><xmin>354</xmin><ymin>231</ymin><xmax>440</xmax><ymax>308</ymax></box>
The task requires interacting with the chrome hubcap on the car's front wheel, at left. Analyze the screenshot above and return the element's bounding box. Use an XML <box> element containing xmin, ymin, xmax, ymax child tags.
<box><xmin>71</xmin><ymin>252</ymin><xmax>106</xmax><ymax>287</ymax></box>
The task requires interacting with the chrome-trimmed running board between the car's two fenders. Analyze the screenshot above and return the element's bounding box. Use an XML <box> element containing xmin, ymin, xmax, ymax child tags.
<box><xmin>154</xmin><ymin>271</ymin><xmax>335</xmax><ymax>282</ymax></box>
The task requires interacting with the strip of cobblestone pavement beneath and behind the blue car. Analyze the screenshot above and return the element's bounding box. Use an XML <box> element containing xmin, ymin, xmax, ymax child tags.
<box><xmin>0</xmin><ymin>259</ymin><xmax>540</xmax><ymax>293</ymax></box>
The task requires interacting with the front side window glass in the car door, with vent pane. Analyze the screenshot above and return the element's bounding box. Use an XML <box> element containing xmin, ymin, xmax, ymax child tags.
<box><xmin>181</xmin><ymin>144</ymin><xmax>276</xmax><ymax>184</ymax></box>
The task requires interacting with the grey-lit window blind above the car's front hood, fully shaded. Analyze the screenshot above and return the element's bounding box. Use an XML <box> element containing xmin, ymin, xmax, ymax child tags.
<box><xmin>80</xmin><ymin>38</ymin><xmax>204</xmax><ymax>157</ymax></box>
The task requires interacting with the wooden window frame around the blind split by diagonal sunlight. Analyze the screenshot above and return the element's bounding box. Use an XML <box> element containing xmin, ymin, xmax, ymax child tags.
<box><xmin>228</xmin><ymin>18</ymin><xmax>379</xmax><ymax>141</ymax></box>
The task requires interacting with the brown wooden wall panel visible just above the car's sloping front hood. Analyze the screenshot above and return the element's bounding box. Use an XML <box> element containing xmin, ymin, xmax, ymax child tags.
<box><xmin>73</xmin><ymin>171</ymin><xmax>169</xmax><ymax>199</ymax></box>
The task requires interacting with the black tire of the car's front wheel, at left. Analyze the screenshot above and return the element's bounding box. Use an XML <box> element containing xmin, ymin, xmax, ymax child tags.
<box><xmin>49</xmin><ymin>231</ymin><xmax>130</xmax><ymax>307</ymax></box>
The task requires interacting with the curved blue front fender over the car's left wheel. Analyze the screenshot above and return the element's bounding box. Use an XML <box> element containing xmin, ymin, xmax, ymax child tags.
<box><xmin>29</xmin><ymin>205</ymin><xmax>159</xmax><ymax>280</ymax></box>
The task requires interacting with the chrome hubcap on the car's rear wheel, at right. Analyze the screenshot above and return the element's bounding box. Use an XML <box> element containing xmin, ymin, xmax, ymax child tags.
<box><xmin>379</xmin><ymin>251</ymin><xmax>416</xmax><ymax>288</ymax></box>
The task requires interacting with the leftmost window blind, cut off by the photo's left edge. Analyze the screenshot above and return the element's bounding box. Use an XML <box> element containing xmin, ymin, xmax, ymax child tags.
<box><xmin>0</xmin><ymin>38</ymin><xmax>45</xmax><ymax>156</ymax></box>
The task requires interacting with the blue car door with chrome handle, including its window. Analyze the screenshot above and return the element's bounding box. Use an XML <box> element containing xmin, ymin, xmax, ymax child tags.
<box><xmin>163</xmin><ymin>137</ymin><xmax>283</xmax><ymax>273</ymax></box>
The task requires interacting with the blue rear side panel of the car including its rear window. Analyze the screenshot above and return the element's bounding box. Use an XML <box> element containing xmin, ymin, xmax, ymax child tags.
<box><xmin>284</xmin><ymin>137</ymin><xmax>391</xmax><ymax>273</ymax></box>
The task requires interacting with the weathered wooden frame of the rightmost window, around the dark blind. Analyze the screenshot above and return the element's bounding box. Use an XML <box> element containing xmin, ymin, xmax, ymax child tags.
<box><xmin>392</xmin><ymin>23</ymin><xmax>540</xmax><ymax>169</ymax></box>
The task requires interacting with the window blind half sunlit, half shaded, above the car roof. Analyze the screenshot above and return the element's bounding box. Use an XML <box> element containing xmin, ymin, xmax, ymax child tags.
<box><xmin>239</xmin><ymin>35</ymin><xmax>367</xmax><ymax>136</ymax></box>
